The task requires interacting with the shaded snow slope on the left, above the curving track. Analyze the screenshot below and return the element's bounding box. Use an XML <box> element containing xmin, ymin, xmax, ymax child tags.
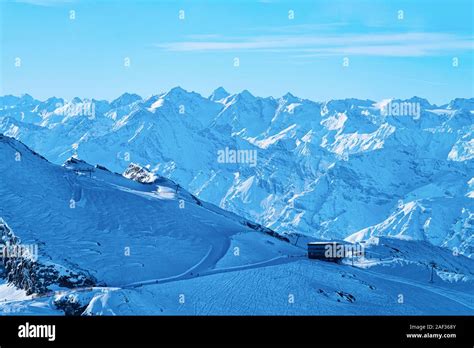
<box><xmin>0</xmin><ymin>136</ymin><xmax>299</xmax><ymax>286</ymax></box>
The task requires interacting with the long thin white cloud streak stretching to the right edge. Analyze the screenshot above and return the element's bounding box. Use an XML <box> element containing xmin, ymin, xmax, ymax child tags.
<box><xmin>155</xmin><ymin>33</ymin><xmax>474</xmax><ymax>57</ymax></box>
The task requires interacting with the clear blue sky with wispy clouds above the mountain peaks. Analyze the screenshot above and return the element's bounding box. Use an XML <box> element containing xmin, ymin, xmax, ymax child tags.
<box><xmin>0</xmin><ymin>0</ymin><xmax>474</xmax><ymax>104</ymax></box>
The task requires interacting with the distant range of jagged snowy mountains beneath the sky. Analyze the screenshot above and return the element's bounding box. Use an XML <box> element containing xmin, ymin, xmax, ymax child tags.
<box><xmin>0</xmin><ymin>87</ymin><xmax>474</xmax><ymax>255</ymax></box>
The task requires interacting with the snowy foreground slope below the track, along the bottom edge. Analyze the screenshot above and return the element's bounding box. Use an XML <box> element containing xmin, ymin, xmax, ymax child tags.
<box><xmin>0</xmin><ymin>246</ymin><xmax>474</xmax><ymax>315</ymax></box>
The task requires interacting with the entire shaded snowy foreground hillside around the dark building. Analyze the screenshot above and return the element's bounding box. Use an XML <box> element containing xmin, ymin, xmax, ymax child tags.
<box><xmin>0</xmin><ymin>135</ymin><xmax>474</xmax><ymax>315</ymax></box>
